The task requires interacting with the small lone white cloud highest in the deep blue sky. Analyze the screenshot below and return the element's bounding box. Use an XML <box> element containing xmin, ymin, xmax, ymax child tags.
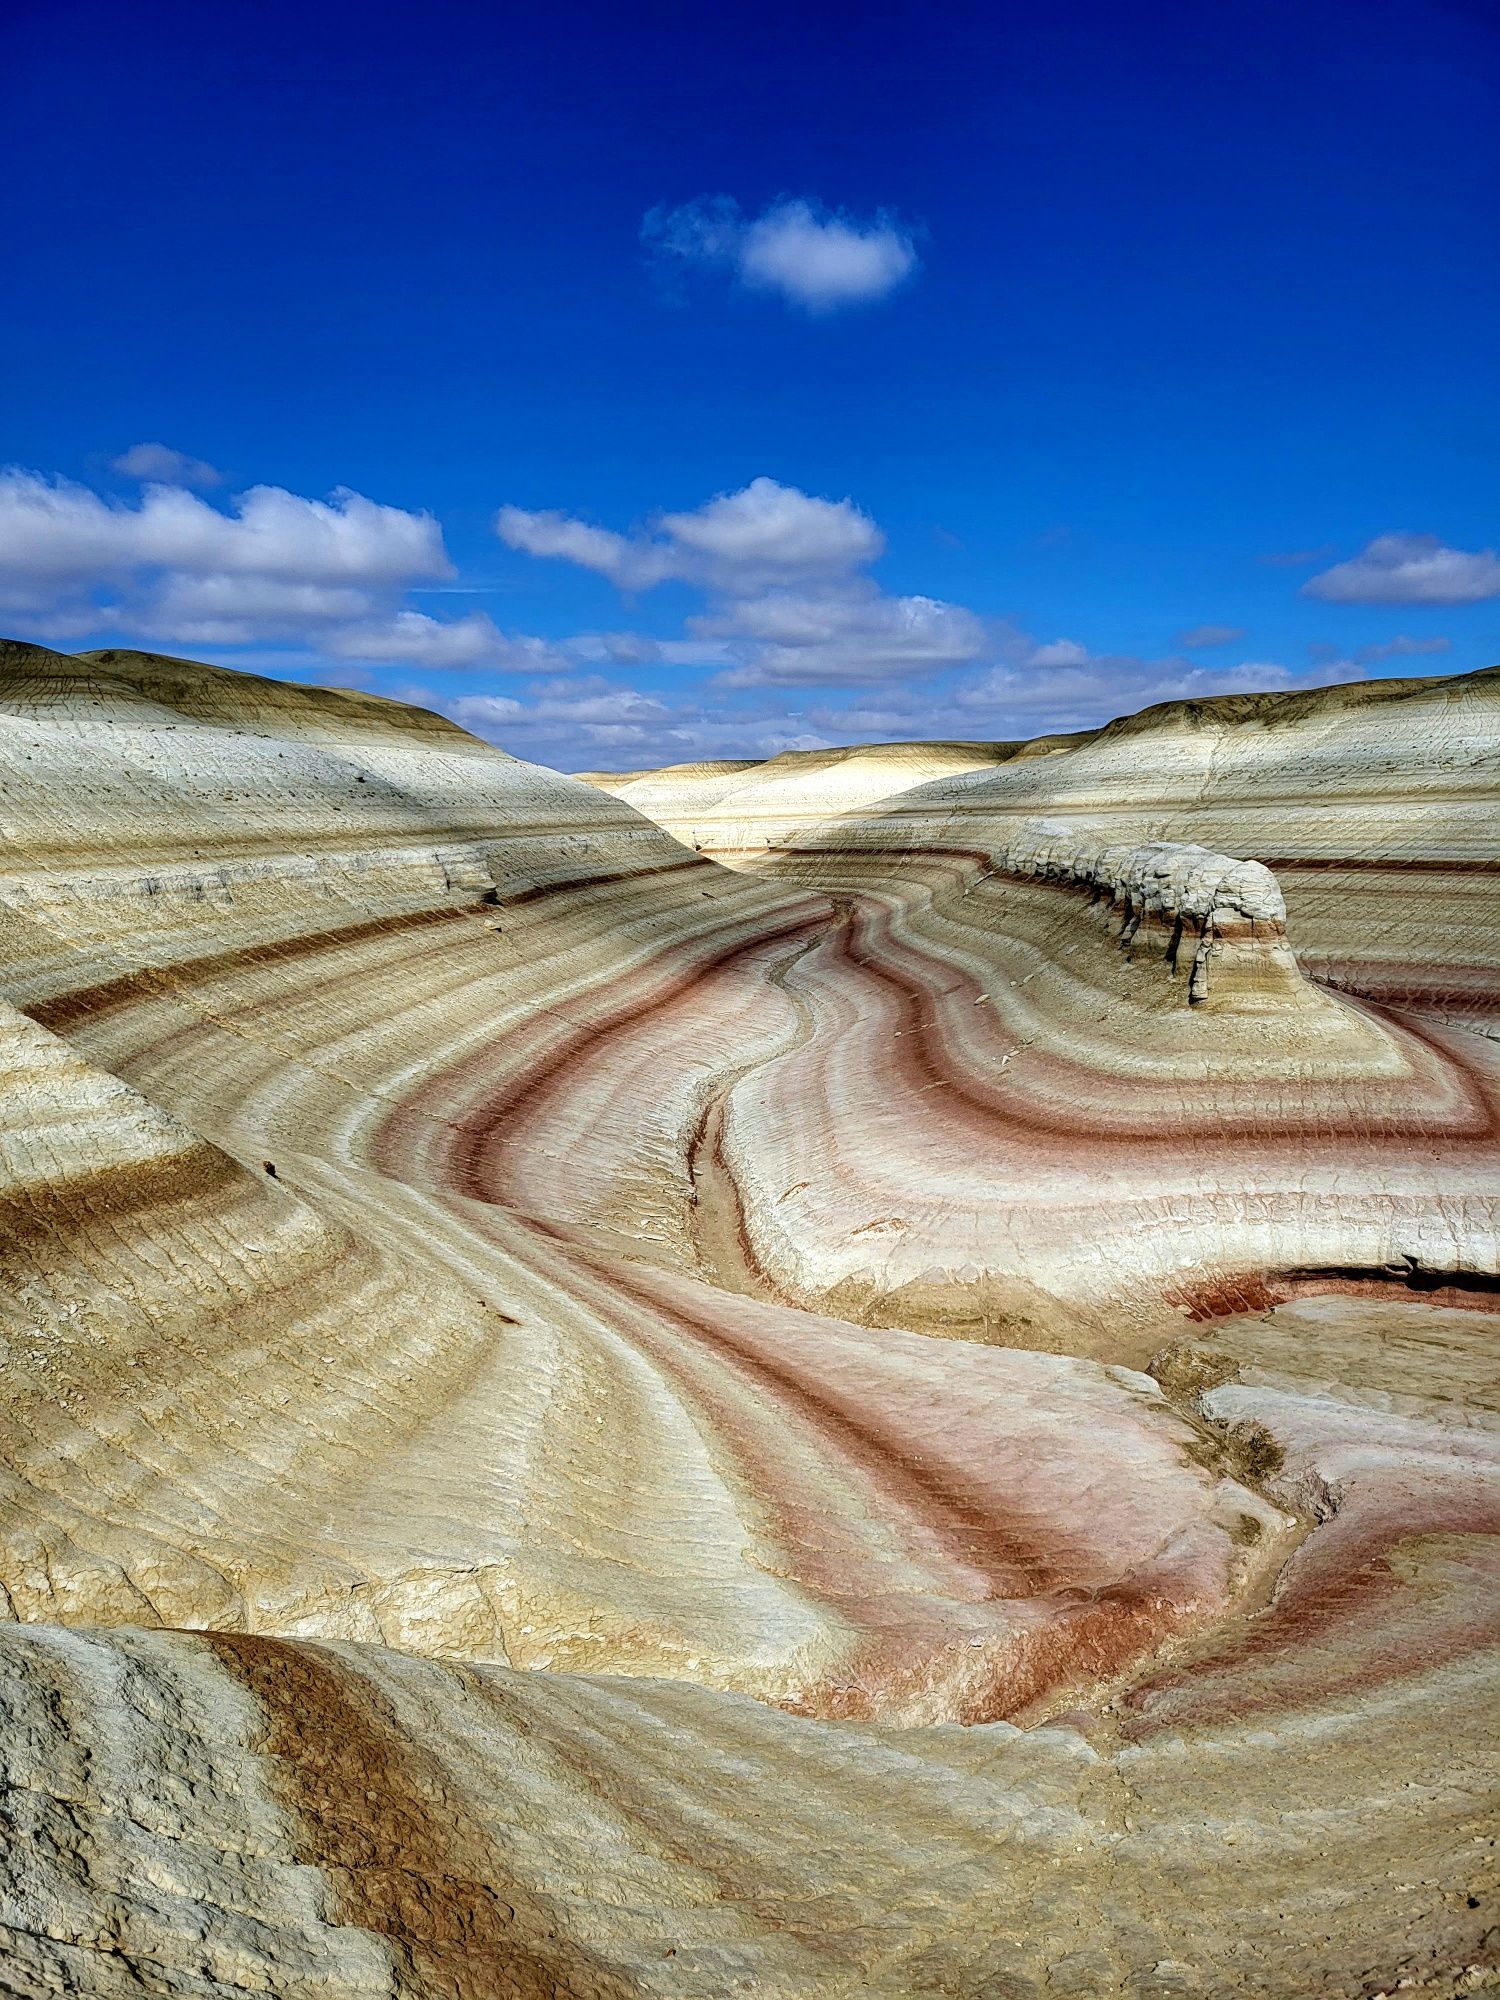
<box><xmin>640</xmin><ymin>194</ymin><xmax>918</xmax><ymax>314</ymax></box>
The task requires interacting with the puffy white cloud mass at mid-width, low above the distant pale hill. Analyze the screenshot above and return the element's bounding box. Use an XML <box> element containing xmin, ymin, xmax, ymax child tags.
<box><xmin>496</xmin><ymin>478</ymin><xmax>988</xmax><ymax>688</ymax></box>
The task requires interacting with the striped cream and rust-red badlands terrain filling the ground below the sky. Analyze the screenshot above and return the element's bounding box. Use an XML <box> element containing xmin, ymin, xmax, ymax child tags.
<box><xmin>0</xmin><ymin>644</ymin><xmax>1500</xmax><ymax>2000</ymax></box>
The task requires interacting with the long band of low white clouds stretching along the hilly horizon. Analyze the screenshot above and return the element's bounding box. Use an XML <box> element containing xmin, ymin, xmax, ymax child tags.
<box><xmin>0</xmin><ymin>460</ymin><xmax>1500</xmax><ymax>770</ymax></box>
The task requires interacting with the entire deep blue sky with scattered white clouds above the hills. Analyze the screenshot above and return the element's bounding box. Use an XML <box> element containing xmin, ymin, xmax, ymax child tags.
<box><xmin>0</xmin><ymin>0</ymin><xmax>1500</xmax><ymax>768</ymax></box>
